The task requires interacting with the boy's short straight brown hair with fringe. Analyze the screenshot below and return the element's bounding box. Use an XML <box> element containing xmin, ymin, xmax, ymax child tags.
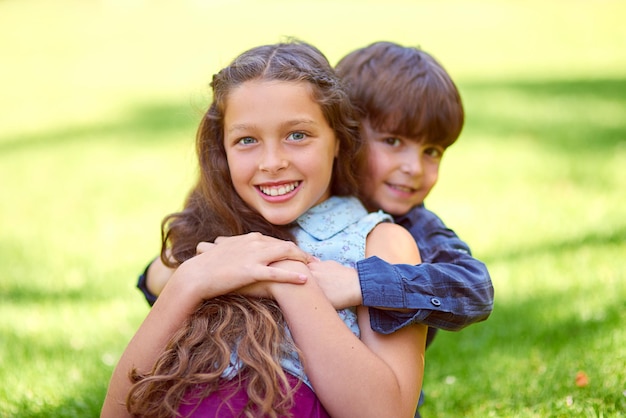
<box><xmin>336</xmin><ymin>42</ymin><xmax>464</xmax><ymax>148</ymax></box>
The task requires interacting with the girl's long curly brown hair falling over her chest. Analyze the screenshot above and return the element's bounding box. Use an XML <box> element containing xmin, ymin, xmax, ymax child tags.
<box><xmin>126</xmin><ymin>40</ymin><xmax>365</xmax><ymax>417</ymax></box>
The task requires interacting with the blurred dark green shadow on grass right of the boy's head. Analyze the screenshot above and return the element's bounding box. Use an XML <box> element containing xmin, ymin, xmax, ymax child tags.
<box><xmin>460</xmin><ymin>79</ymin><xmax>626</xmax><ymax>154</ymax></box>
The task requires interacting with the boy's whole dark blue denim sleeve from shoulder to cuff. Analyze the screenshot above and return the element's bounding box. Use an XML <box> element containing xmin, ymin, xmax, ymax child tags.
<box><xmin>357</xmin><ymin>206</ymin><xmax>493</xmax><ymax>333</ymax></box>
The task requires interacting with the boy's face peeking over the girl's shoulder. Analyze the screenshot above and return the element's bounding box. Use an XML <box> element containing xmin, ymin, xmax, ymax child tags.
<box><xmin>361</xmin><ymin>120</ymin><xmax>445</xmax><ymax>215</ymax></box>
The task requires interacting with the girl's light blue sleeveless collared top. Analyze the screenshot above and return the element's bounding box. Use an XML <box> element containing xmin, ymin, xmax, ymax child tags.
<box><xmin>223</xmin><ymin>196</ymin><xmax>393</xmax><ymax>386</ymax></box>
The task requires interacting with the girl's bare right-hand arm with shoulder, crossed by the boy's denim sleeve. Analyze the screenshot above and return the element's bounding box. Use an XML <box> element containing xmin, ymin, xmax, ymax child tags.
<box><xmin>269</xmin><ymin>223</ymin><xmax>427</xmax><ymax>418</ymax></box>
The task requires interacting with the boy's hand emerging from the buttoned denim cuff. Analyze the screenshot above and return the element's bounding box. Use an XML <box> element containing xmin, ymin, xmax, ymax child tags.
<box><xmin>308</xmin><ymin>259</ymin><xmax>363</xmax><ymax>309</ymax></box>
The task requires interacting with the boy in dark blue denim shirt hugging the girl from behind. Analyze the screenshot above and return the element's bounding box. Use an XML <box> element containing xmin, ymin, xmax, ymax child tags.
<box><xmin>138</xmin><ymin>42</ymin><xmax>493</xmax><ymax>414</ymax></box>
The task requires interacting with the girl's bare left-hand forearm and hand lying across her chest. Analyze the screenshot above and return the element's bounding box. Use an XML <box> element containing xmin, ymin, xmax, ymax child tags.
<box><xmin>101</xmin><ymin>238</ymin><xmax>306</xmax><ymax>418</ymax></box>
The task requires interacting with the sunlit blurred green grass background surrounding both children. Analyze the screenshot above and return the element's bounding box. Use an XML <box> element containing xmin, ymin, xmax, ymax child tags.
<box><xmin>0</xmin><ymin>0</ymin><xmax>626</xmax><ymax>417</ymax></box>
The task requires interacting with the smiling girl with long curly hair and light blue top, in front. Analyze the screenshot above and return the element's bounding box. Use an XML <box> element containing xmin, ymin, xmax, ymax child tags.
<box><xmin>102</xmin><ymin>42</ymin><xmax>426</xmax><ymax>417</ymax></box>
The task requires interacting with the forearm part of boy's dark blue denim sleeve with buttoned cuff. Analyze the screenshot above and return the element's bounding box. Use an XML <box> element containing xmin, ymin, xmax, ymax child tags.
<box><xmin>357</xmin><ymin>257</ymin><xmax>493</xmax><ymax>334</ymax></box>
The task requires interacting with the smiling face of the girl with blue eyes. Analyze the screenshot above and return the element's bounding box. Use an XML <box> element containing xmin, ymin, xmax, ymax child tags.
<box><xmin>224</xmin><ymin>80</ymin><xmax>339</xmax><ymax>225</ymax></box>
